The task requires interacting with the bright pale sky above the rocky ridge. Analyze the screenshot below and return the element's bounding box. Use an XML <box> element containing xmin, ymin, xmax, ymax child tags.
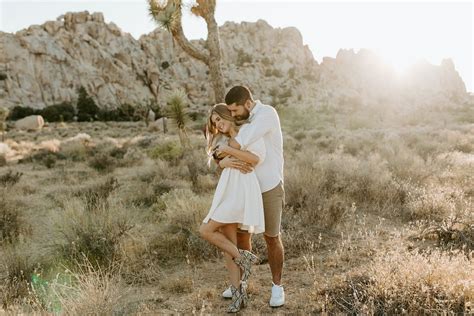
<box><xmin>0</xmin><ymin>0</ymin><xmax>474</xmax><ymax>92</ymax></box>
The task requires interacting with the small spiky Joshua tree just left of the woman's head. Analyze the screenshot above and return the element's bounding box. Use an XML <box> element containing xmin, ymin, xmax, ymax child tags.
<box><xmin>166</xmin><ymin>90</ymin><xmax>189</xmax><ymax>147</ymax></box>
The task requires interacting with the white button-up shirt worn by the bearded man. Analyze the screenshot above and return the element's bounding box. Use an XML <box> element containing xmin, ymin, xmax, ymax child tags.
<box><xmin>235</xmin><ymin>100</ymin><xmax>283</xmax><ymax>193</ymax></box>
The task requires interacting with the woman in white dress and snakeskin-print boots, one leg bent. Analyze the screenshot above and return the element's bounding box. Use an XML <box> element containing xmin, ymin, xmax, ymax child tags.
<box><xmin>199</xmin><ymin>103</ymin><xmax>266</xmax><ymax>312</ymax></box>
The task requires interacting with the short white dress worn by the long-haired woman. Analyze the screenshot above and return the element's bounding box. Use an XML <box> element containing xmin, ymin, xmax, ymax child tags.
<box><xmin>203</xmin><ymin>124</ymin><xmax>266</xmax><ymax>234</ymax></box>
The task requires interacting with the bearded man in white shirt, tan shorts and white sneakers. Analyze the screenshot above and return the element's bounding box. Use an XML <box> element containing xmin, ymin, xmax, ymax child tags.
<box><xmin>219</xmin><ymin>86</ymin><xmax>285</xmax><ymax>307</ymax></box>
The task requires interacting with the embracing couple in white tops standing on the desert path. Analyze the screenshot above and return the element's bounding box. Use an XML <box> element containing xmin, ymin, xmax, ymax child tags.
<box><xmin>199</xmin><ymin>86</ymin><xmax>285</xmax><ymax>313</ymax></box>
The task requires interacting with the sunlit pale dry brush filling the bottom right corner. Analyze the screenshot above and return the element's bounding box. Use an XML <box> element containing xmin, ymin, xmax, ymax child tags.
<box><xmin>327</xmin><ymin>249</ymin><xmax>474</xmax><ymax>315</ymax></box>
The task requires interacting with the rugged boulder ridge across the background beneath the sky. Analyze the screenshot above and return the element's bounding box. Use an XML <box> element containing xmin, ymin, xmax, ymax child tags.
<box><xmin>0</xmin><ymin>11</ymin><xmax>467</xmax><ymax>108</ymax></box>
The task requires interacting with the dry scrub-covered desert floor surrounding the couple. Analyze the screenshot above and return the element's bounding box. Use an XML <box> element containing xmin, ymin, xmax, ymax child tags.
<box><xmin>0</xmin><ymin>106</ymin><xmax>474</xmax><ymax>314</ymax></box>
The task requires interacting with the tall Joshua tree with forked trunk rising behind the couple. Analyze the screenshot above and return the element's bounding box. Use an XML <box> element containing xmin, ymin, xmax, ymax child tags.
<box><xmin>147</xmin><ymin>0</ymin><xmax>225</xmax><ymax>103</ymax></box>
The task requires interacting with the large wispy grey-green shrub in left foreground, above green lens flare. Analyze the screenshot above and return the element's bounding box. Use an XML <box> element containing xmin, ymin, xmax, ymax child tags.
<box><xmin>55</xmin><ymin>201</ymin><xmax>134</xmax><ymax>269</ymax></box>
